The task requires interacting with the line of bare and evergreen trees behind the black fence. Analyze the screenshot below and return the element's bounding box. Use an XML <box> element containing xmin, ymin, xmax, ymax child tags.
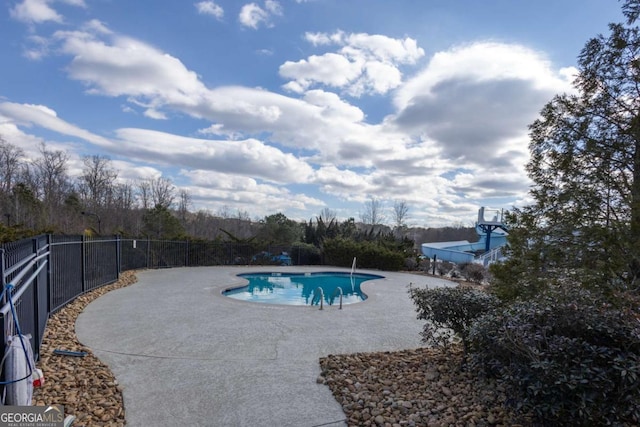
<box><xmin>0</xmin><ymin>140</ymin><xmax>477</xmax><ymax>251</ymax></box>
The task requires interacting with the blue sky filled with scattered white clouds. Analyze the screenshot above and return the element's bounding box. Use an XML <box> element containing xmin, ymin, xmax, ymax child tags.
<box><xmin>0</xmin><ymin>0</ymin><xmax>623</xmax><ymax>227</ymax></box>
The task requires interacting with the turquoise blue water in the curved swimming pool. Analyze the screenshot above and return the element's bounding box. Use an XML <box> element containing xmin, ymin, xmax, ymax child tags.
<box><xmin>223</xmin><ymin>272</ymin><xmax>384</xmax><ymax>305</ymax></box>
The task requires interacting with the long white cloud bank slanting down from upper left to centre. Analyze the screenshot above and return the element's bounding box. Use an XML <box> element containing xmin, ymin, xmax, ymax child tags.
<box><xmin>42</xmin><ymin>22</ymin><xmax>371</xmax><ymax>161</ymax></box>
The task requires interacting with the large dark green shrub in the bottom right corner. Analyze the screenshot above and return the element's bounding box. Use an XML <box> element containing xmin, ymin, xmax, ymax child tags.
<box><xmin>469</xmin><ymin>285</ymin><xmax>640</xmax><ymax>426</ymax></box>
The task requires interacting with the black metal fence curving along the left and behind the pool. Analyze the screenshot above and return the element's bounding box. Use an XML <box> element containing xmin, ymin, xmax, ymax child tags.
<box><xmin>0</xmin><ymin>235</ymin><xmax>301</xmax><ymax>359</ymax></box>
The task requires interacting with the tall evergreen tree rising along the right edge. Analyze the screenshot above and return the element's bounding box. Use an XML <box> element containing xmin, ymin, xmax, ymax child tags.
<box><xmin>495</xmin><ymin>0</ymin><xmax>640</xmax><ymax>289</ymax></box>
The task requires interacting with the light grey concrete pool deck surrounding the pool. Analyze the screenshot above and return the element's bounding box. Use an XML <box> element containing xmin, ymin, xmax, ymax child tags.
<box><xmin>76</xmin><ymin>267</ymin><xmax>453</xmax><ymax>427</ymax></box>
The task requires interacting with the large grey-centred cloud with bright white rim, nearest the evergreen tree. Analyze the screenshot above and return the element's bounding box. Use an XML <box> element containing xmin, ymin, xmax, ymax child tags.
<box><xmin>389</xmin><ymin>43</ymin><xmax>570</xmax><ymax>172</ymax></box>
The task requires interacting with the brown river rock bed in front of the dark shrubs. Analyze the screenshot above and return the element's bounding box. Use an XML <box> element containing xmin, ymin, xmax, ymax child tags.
<box><xmin>318</xmin><ymin>348</ymin><xmax>526</xmax><ymax>427</ymax></box>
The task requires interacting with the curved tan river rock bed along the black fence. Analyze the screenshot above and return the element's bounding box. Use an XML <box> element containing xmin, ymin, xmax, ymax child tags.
<box><xmin>33</xmin><ymin>271</ymin><xmax>136</xmax><ymax>427</ymax></box>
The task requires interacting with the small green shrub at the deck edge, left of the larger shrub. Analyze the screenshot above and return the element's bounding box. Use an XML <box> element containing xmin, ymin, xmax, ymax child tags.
<box><xmin>409</xmin><ymin>287</ymin><xmax>498</xmax><ymax>354</ymax></box>
